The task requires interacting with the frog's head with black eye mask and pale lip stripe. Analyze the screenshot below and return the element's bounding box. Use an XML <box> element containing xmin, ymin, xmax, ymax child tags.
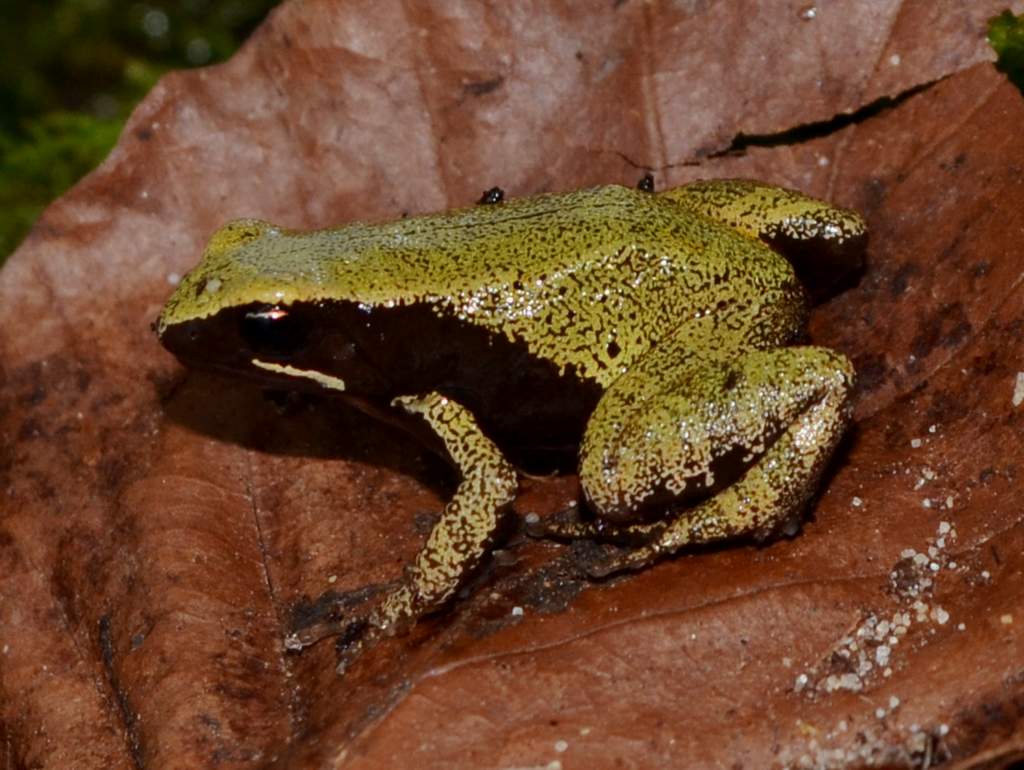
<box><xmin>154</xmin><ymin>219</ymin><xmax>397</xmax><ymax>395</ymax></box>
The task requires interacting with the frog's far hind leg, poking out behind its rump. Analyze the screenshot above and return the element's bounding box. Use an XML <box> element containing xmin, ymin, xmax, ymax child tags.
<box><xmin>657</xmin><ymin>179</ymin><xmax>867</xmax><ymax>300</ymax></box>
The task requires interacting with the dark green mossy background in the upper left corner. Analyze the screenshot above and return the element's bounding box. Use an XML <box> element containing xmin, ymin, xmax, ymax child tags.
<box><xmin>0</xmin><ymin>0</ymin><xmax>276</xmax><ymax>262</ymax></box>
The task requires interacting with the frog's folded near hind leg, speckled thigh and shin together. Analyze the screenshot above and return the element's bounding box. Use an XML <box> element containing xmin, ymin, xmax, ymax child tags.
<box><xmin>581</xmin><ymin>347</ymin><xmax>853</xmax><ymax>574</ymax></box>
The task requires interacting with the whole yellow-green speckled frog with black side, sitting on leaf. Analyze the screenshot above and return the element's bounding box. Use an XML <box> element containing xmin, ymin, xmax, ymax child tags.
<box><xmin>155</xmin><ymin>177</ymin><xmax>867</xmax><ymax>671</ymax></box>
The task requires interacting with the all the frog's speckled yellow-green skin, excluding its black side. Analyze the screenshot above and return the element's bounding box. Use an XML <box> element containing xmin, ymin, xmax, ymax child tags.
<box><xmin>157</xmin><ymin>181</ymin><xmax>864</xmax><ymax>667</ymax></box>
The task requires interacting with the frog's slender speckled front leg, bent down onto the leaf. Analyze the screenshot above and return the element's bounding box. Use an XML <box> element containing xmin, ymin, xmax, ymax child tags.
<box><xmin>371</xmin><ymin>393</ymin><xmax>516</xmax><ymax>633</ymax></box>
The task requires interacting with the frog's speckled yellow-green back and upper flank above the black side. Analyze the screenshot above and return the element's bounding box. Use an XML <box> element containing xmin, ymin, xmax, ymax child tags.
<box><xmin>182</xmin><ymin>186</ymin><xmax>801</xmax><ymax>385</ymax></box>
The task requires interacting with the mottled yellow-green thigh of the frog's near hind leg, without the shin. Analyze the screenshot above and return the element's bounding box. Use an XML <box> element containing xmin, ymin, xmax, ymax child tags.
<box><xmin>580</xmin><ymin>316</ymin><xmax>852</xmax><ymax>520</ymax></box>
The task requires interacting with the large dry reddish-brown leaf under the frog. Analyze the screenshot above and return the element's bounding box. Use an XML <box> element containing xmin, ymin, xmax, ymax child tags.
<box><xmin>0</xmin><ymin>0</ymin><xmax>1024</xmax><ymax>769</ymax></box>
